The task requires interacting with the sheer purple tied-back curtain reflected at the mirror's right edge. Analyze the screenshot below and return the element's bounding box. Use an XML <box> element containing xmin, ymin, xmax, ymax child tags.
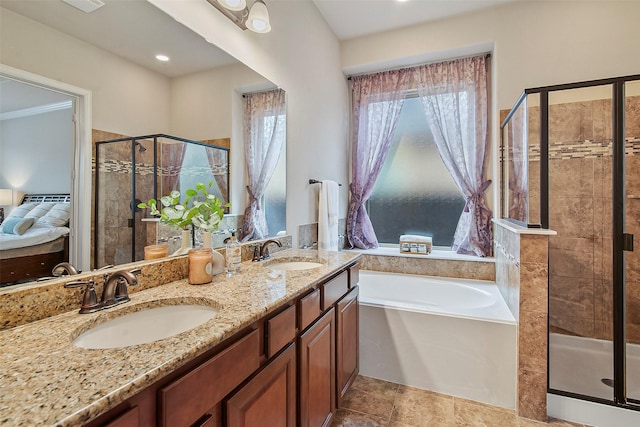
<box><xmin>242</xmin><ymin>89</ymin><xmax>286</xmax><ymax>241</ymax></box>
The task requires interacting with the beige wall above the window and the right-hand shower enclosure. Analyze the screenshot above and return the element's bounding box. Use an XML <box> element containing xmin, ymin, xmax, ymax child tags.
<box><xmin>341</xmin><ymin>0</ymin><xmax>640</xmax><ymax>219</ymax></box>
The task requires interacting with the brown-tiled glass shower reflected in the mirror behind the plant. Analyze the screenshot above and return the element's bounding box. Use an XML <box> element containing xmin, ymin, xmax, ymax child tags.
<box><xmin>93</xmin><ymin>134</ymin><xmax>229</xmax><ymax>267</ymax></box>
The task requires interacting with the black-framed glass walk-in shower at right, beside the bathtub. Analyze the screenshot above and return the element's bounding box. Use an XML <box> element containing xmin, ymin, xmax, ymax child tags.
<box><xmin>501</xmin><ymin>75</ymin><xmax>640</xmax><ymax>409</ymax></box>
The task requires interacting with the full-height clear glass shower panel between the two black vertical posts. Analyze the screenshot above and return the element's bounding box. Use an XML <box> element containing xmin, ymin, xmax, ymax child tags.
<box><xmin>548</xmin><ymin>85</ymin><xmax>614</xmax><ymax>401</ymax></box>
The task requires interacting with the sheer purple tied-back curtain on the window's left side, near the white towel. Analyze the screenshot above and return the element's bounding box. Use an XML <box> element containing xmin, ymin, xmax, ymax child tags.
<box><xmin>347</xmin><ymin>69</ymin><xmax>411</xmax><ymax>249</ymax></box>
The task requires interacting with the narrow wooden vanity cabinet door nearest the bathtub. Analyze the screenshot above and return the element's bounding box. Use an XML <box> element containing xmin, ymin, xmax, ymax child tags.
<box><xmin>336</xmin><ymin>286</ymin><xmax>360</xmax><ymax>407</ymax></box>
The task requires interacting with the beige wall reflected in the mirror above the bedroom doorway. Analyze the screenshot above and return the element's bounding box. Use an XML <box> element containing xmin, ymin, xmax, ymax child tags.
<box><xmin>0</xmin><ymin>9</ymin><xmax>170</xmax><ymax>135</ymax></box>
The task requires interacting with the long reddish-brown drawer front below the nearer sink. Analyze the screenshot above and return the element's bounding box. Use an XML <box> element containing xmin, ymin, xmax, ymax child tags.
<box><xmin>159</xmin><ymin>330</ymin><xmax>260</xmax><ymax>427</ymax></box>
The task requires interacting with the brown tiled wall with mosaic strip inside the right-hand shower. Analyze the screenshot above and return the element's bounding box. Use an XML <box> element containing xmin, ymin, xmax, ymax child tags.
<box><xmin>528</xmin><ymin>97</ymin><xmax>640</xmax><ymax>343</ymax></box>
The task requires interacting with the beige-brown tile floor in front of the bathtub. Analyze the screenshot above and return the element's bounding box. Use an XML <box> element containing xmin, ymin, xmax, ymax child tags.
<box><xmin>332</xmin><ymin>376</ymin><xmax>582</xmax><ymax>427</ymax></box>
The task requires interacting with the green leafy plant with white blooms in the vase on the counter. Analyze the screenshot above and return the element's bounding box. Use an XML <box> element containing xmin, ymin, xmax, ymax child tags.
<box><xmin>138</xmin><ymin>182</ymin><xmax>231</xmax><ymax>232</ymax></box>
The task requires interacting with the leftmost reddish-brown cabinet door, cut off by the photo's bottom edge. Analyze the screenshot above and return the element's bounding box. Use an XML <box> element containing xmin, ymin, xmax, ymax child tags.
<box><xmin>226</xmin><ymin>343</ymin><xmax>296</xmax><ymax>427</ymax></box>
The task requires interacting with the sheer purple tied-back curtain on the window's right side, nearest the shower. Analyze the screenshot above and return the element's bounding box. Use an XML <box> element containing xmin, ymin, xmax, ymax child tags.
<box><xmin>415</xmin><ymin>55</ymin><xmax>493</xmax><ymax>256</ymax></box>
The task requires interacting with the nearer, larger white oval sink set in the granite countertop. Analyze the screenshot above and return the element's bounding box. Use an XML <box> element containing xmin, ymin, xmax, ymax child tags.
<box><xmin>73</xmin><ymin>304</ymin><xmax>218</xmax><ymax>349</ymax></box>
